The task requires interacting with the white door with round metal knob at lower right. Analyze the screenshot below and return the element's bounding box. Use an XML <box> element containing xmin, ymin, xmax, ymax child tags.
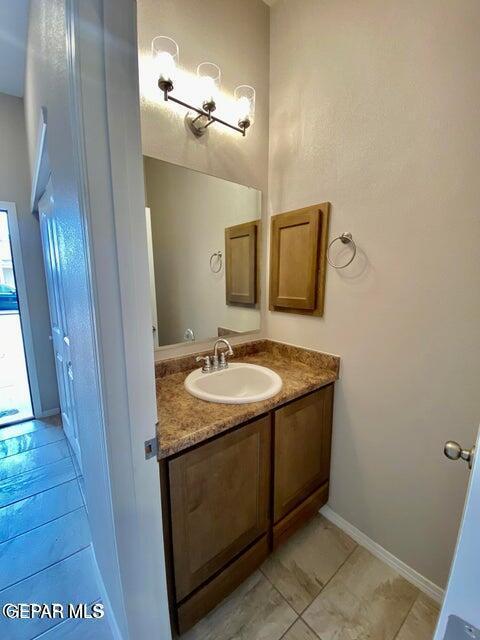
<box><xmin>434</xmin><ymin>429</ymin><xmax>480</xmax><ymax>640</ymax></box>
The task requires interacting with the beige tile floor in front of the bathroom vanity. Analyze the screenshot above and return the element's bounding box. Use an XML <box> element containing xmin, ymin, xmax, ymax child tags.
<box><xmin>182</xmin><ymin>515</ymin><xmax>438</xmax><ymax>640</ymax></box>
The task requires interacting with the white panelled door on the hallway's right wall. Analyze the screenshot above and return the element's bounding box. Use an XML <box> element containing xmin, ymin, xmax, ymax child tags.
<box><xmin>38</xmin><ymin>180</ymin><xmax>82</xmax><ymax>468</ymax></box>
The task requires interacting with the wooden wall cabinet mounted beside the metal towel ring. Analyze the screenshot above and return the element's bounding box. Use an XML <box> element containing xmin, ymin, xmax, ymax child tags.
<box><xmin>270</xmin><ymin>202</ymin><xmax>330</xmax><ymax>316</ymax></box>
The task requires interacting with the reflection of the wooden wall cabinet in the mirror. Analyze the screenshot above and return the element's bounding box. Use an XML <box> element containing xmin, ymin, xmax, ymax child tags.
<box><xmin>225</xmin><ymin>221</ymin><xmax>258</xmax><ymax>305</ymax></box>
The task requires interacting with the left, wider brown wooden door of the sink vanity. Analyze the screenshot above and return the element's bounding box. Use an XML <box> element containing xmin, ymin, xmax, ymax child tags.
<box><xmin>169</xmin><ymin>416</ymin><xmax>271</xmax><ymax>602</ymax></box>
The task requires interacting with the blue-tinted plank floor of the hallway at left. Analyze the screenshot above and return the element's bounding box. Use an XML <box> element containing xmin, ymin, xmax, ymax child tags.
<box><xmin>0</xmin><ymin>419</ymin><xmax>113</xmax><ymax>640</ymax></box>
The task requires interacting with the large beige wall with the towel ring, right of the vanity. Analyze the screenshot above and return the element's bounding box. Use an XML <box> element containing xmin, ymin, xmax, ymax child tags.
<box><xmin>268</xmin><ymin>0</ymin><xmax>480</xmax><ymax>586</ymax></box>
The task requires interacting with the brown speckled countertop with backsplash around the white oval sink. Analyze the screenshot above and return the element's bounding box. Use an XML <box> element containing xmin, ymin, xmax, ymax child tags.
<box><xmin>156</xmin><ymin>340</ymin><xmax>340</xmax><ymax>459</ymax></box>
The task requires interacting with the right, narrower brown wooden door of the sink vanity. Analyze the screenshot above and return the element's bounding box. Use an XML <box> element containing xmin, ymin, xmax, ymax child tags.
<box><xmin>274</xmin><ymin>385</ymin><xmax>333</xmax><ymax>522</ymax></box>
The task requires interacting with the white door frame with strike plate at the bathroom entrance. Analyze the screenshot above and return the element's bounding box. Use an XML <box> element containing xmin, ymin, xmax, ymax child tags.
<box><xmin>66</xmin><ymin>0</ymin><xmax>171</xmax><ymax>640</ymax></box>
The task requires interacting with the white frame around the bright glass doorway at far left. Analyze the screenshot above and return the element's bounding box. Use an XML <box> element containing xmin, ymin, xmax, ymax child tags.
<box><xmin>0</xmin><ymin>201</ymin><xmax>41</xmax><ymax>418</ymax></box>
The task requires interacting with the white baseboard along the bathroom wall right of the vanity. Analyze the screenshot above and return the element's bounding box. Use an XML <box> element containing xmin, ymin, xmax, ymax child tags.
<box><xmin>320</xmin><ymin>505</ymin><xmax>445</xmax><ymax>604</ymax></box>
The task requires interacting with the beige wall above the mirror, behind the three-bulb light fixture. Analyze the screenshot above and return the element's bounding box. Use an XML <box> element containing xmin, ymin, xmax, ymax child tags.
<box><xmin>137</xmin><ymin>0</ymin><xmax>269</xmax><ymax>356</ymax></box>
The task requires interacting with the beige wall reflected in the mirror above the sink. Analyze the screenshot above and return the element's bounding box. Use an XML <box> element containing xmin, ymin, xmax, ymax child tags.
<box><xmin>144</xmin><ymin>157</ymin><xmax>261</xmax><ymax>346</ymax></box>
